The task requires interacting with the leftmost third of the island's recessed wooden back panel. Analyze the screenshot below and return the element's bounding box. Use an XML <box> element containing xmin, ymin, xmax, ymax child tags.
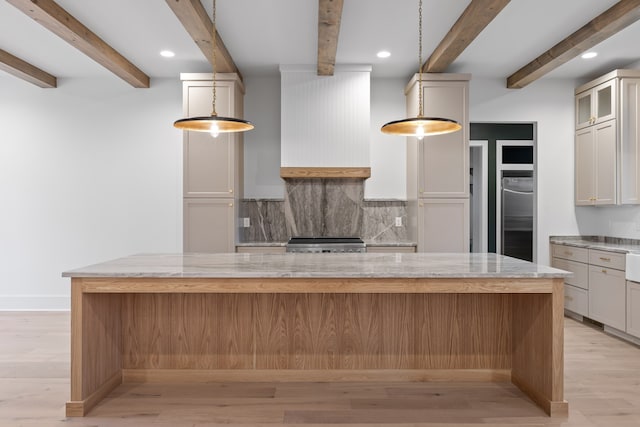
<box><xmin>123</xmin><ymin>293</ymin><xmax>254</xmax><ymax>372</ymax></box>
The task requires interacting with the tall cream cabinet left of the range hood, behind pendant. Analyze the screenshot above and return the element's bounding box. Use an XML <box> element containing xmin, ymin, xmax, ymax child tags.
<box><xmin>181</xmin><ymin>73</ymin><xmax>244</xmax><ymax>252</ymax></box>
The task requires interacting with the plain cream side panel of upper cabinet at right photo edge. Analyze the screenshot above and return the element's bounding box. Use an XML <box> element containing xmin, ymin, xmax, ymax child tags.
<box><xmin>618</xmin><ymin>79</ymin><xmax>640</xmax><ymax>205</ymax></box>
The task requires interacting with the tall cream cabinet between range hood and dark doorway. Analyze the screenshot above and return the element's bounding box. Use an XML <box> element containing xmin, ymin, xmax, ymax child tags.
<box><xmin>405</xmin><ymin>73</ymin><xmax>471</xmax><ymax>252</ymax></box>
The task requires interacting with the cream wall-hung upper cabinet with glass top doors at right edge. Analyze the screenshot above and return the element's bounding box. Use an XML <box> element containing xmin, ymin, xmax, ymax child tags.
<box><xmin>575</xmin><ymin>70</ymin><xmax>640</xmax><ymax>206</ymax></box>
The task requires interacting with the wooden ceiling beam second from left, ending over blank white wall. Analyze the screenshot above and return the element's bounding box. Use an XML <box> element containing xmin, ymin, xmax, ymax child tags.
<box><xmin>7</xmin><ymin>0</ymin><xmax>149</xmax><ymax>88</ymax></box>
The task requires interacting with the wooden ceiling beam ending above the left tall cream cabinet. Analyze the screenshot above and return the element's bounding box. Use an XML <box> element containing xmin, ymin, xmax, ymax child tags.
<box><xmin>166</xmin><ymin>0</ymin><xmax>242</xmax><ymax>80</ymax></box>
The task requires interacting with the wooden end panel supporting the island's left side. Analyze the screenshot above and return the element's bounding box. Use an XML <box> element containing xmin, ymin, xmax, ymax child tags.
<box><xmin>66</xmin><ymin>278</ymin><xmax>122</xmax><ymax>416</ymax></box>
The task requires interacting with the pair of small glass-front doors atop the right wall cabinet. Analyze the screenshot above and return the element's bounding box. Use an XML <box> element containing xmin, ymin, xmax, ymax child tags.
<box><xmin>576</xmin><ymin>79</ymin><xmax>617</xmax><ymax>129</ymax></box>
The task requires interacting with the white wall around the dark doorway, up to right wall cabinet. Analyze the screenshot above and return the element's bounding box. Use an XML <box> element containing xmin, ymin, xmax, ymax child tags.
<box><xmin>469</xmin><ymin>77</ymin><xmax>579</xmax><ymax>264</ymax></box>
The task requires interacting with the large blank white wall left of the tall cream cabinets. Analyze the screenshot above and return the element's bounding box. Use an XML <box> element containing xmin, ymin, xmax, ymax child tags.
<box><xmin>0</xmin><ymin>75</ymin><xmax>182</xmax><ymax>310</ymax></box>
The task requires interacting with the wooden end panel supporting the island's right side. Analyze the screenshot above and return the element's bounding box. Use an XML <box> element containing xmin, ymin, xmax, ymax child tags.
<box><xmin>512</xmin><ymin>279</ymin><xmax>568</xmax><ymax>415</ymax></box>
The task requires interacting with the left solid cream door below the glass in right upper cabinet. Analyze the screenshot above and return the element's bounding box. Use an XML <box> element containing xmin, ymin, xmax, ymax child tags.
<box><xmin>575</xmin><ymin>127</ymin><xmax>595</xmax><ymax>206</ymax></box>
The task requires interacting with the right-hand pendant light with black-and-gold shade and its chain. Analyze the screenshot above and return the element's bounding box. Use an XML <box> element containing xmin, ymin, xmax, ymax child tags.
<box><xmin>380</xmin><ymin>0</ymin><xmax>462</xmax><ymax>140</ymax></box>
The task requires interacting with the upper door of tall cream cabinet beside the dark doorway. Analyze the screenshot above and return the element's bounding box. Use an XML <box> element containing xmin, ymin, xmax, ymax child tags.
<box><xmin>418</xmin><ymin>82</ymin><xmax>469</xmax><ymax>198</ymax></box>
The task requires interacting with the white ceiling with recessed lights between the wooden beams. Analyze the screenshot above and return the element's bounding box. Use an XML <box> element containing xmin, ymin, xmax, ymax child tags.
<box><xmin>0</xmin><ymin>0</ymin><xmax>640</xmax><ymax>85</ymax></box>
